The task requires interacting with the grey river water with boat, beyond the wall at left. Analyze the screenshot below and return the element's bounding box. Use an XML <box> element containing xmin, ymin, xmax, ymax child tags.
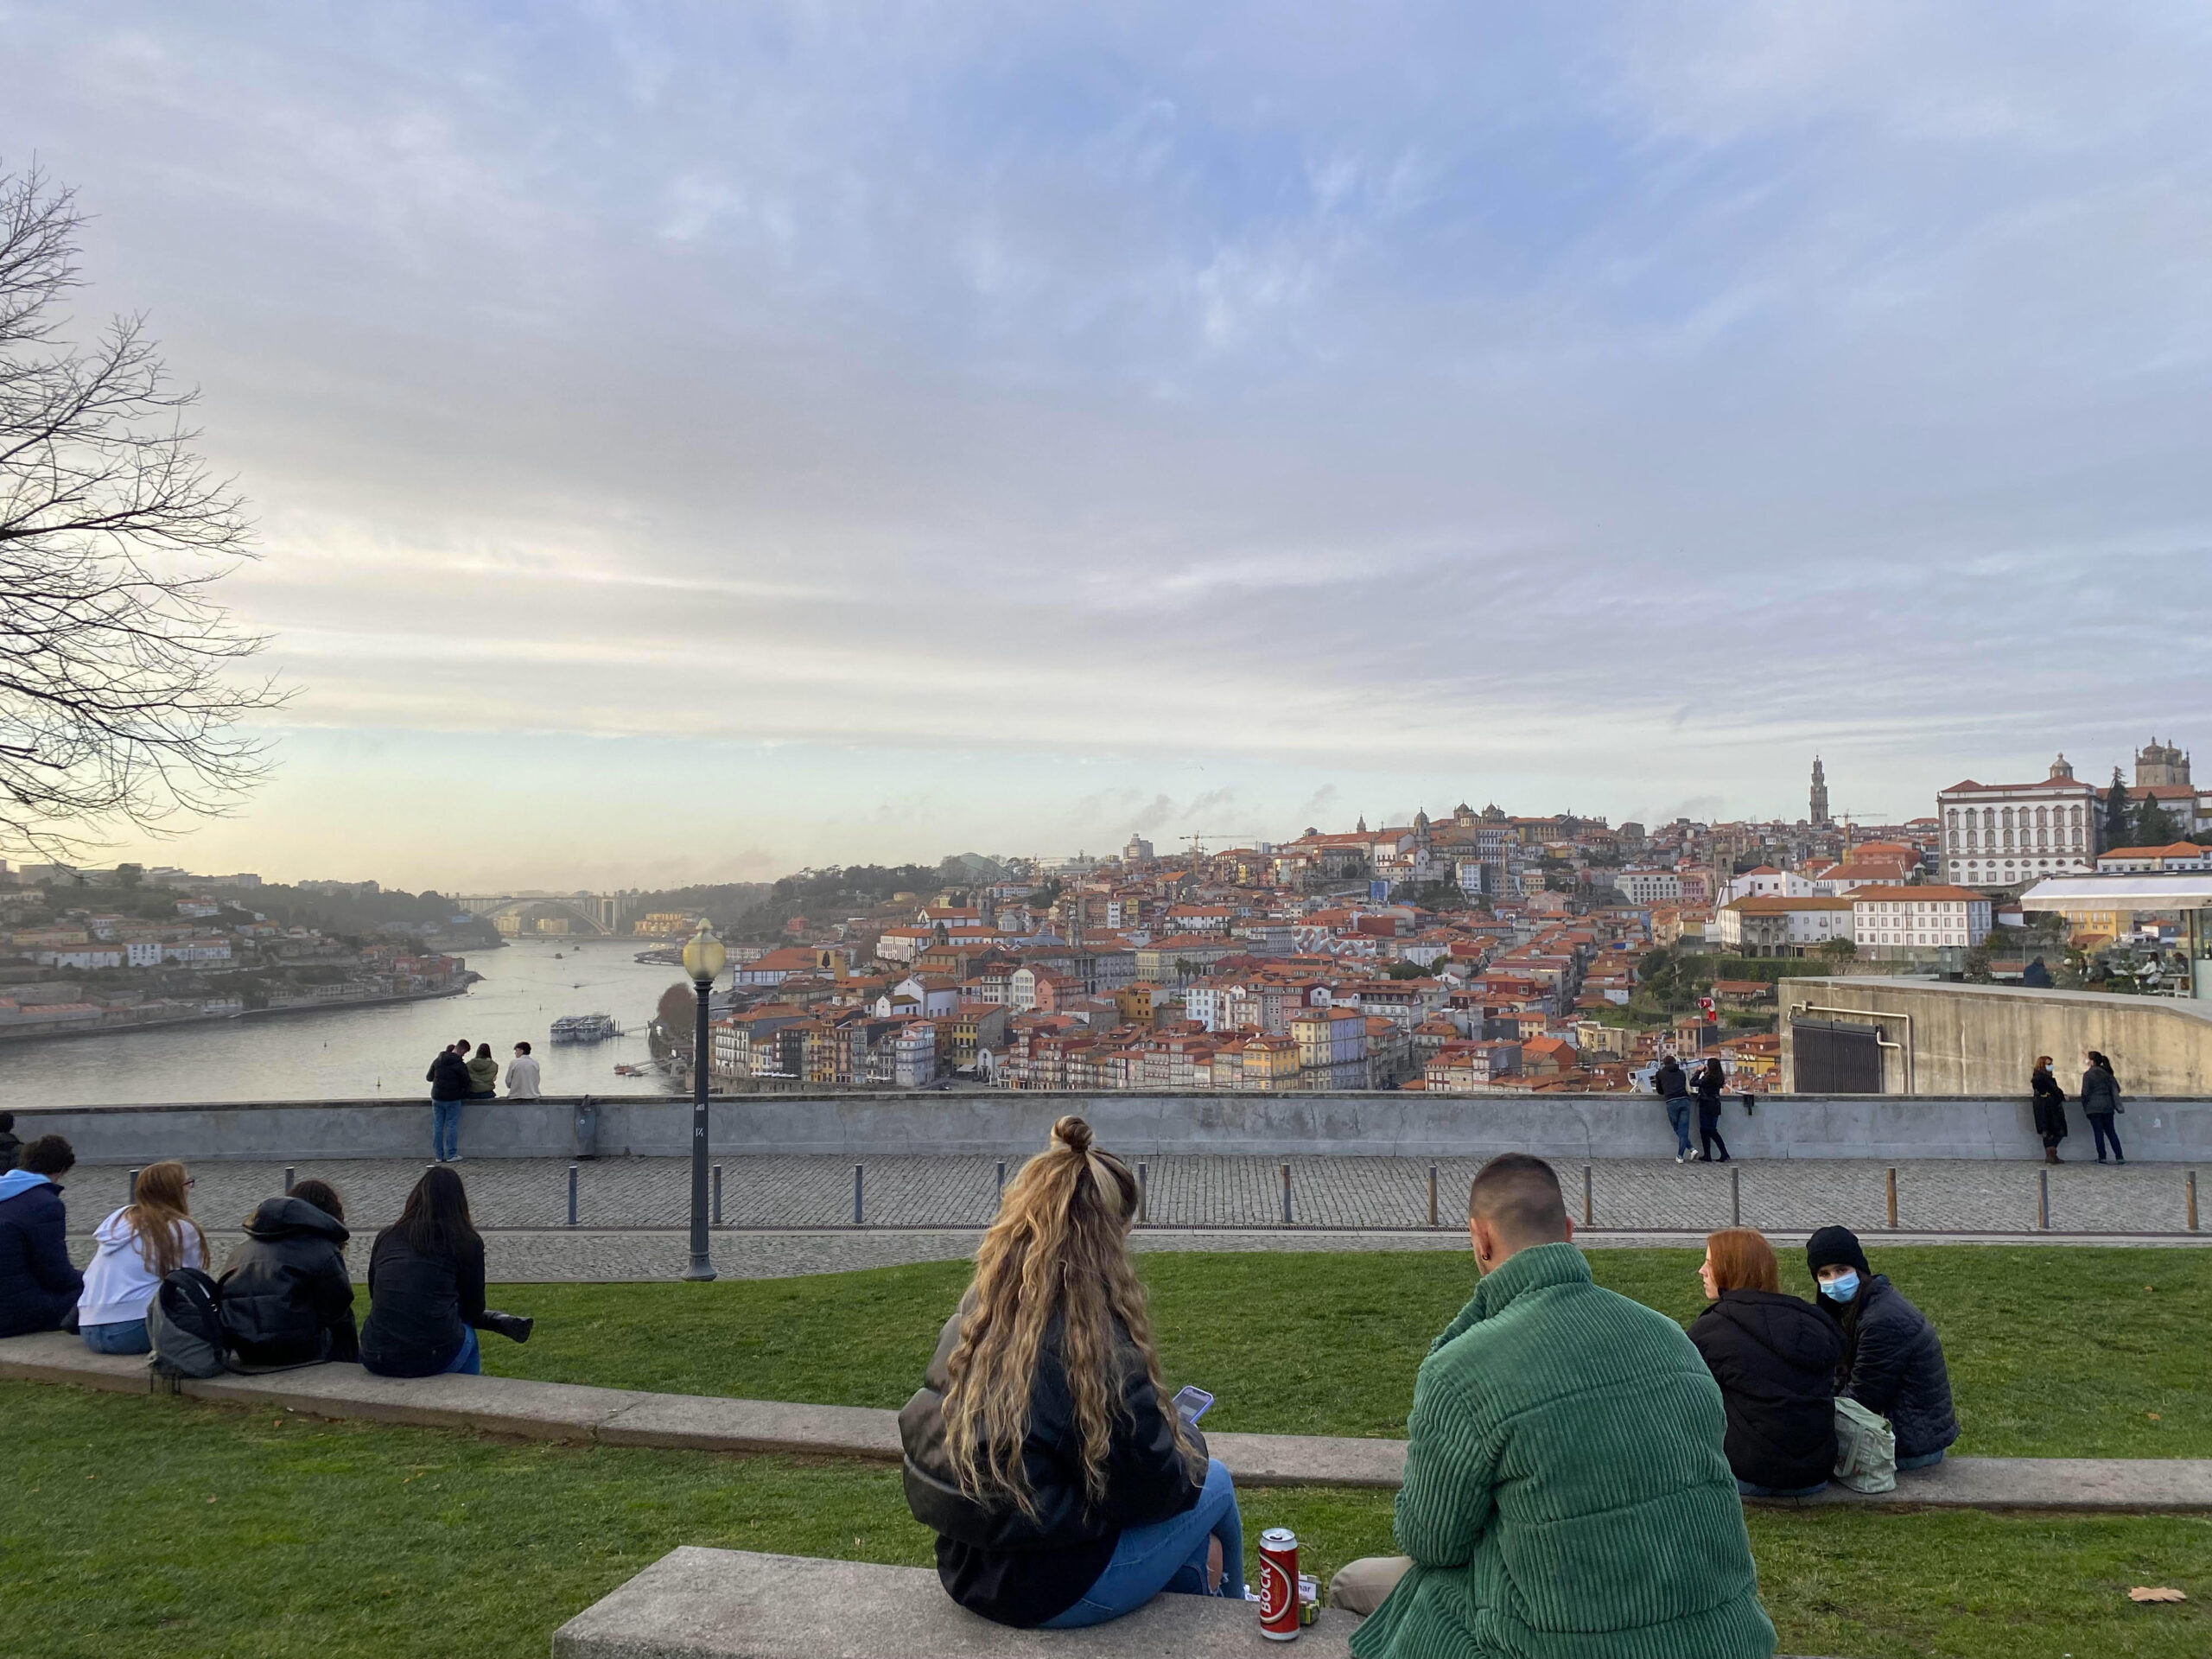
<box><xmin>0</xmin><ymin>940</ymin><xmax>688</xmax><ymax>1109</ymax></box>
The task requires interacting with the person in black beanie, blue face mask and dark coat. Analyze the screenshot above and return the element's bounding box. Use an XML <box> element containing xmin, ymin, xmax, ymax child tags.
<box><xmin>1805</xmin><ymin>1228</ymin><xmax>1958</xmax><ymax>1469</ymax></box>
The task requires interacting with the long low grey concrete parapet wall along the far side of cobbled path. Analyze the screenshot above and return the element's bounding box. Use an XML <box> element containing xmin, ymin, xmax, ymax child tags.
<box><xmin>16</xmin><ymin>1093</ymin><xmax>2212</xmax><ymax>1164</ymax></box>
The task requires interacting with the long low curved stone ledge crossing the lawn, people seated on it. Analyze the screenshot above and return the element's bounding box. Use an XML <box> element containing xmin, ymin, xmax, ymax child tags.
<box><xmin>0</xmin><ymin>1332</ymin><xmax>2212</xmax><ymax>1513</ymax></box>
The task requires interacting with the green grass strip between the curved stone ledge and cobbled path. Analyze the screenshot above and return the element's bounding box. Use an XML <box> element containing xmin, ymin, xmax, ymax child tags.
<box><xmin>485</xmin><ymin>1245</ymin><xmax>2212</xmax><ymax>1458</ymax></box>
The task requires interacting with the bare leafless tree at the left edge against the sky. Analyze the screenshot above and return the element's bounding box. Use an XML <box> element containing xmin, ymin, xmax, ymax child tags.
<box><xmin>0</xmin><ymin>166</ymin><xmax>281</xmax><ymax>856</ymax></box>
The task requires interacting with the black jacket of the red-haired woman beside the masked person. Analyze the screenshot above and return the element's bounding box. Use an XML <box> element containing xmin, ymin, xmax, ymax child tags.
<box><xmin>1690</xmin><ymin>1289</ymin><xmax>1842</xmax><ymax>1491</ymax></box>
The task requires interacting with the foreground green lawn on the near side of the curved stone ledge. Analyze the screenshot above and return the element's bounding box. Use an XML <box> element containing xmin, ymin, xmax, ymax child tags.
<box><xmin>0</xmin><ymin>1382</ymin><xmax>2212</xmax><ymax>1659</ymax></box>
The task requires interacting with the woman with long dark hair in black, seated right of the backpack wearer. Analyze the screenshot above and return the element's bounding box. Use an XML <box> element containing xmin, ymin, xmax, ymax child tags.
<box><xmin>360</xmin><ymin>1164</ymin><xmax>531</xmax><ymax>1376</ymax></box>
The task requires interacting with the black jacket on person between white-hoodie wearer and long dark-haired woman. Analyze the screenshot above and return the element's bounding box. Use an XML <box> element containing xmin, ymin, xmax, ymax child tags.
<box><xmin>221</xmin><ymin>1197</ymin><xmax>360</xmax><ymax>1365</ymax></box>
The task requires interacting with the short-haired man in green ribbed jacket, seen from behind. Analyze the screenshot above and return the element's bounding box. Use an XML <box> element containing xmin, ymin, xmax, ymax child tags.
<box><xmin>1332</xmin><ymin>1153</ymin><xmax>1774</xmax><ymax>1659</ymax></box>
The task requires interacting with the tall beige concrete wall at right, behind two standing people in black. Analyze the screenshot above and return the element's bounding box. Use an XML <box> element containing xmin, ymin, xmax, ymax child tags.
<box><xmin>1777</xmin><ymin>976</ymin><xmax>2212</xmax><ymax>1096</ymax></box>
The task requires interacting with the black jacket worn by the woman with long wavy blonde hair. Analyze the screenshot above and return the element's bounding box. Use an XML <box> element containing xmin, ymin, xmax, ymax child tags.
<box><xmin>898</xmin><ymin>1314</ymin><xmax>1205</xmax><ymax>1626</ymax></box>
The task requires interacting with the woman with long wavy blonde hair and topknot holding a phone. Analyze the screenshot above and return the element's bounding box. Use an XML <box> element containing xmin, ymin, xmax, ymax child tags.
<box><xmin>898</xmin><ymin>1117</ymin><xmax>1243</xmax><ymax>1630</ymax></box>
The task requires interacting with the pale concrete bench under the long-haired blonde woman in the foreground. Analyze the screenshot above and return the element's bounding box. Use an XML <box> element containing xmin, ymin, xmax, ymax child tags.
<box><xmin>553</xmin><ymin>1546</ymin><xmax>1360</xmax><ymax>1659</ymax></box>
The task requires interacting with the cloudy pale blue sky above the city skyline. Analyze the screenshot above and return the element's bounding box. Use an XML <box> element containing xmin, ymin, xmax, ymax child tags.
<box><xmin>0</xmin><ymin>0</ymin><xmax>2212</xmax><ymax>892</ymax></box>
